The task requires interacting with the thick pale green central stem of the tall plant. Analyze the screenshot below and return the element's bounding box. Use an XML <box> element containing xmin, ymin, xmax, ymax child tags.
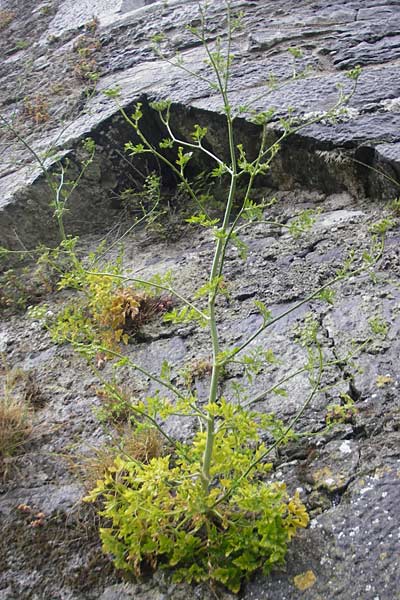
<box><xmin>201</xmin><ymin>102</ymin><xmax>237</xmax><ymax>494</ymax></box>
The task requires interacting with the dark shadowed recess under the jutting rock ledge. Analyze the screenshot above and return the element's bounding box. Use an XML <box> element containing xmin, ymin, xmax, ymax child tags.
<box><xmin>0</xmin><ymin>95</ymin><xmax>395</xmax><ymax>251</ymax></box>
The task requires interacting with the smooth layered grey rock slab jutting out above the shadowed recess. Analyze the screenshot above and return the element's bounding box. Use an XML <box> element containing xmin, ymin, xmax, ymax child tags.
<box><xmin>0</xmin><ymin>0</ymin><xmax>400</xmax><ymax>247</ymax></box>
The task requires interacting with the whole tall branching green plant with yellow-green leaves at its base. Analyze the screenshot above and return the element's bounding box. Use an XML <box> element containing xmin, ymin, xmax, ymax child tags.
<box><xmin>42</xmin><ymin>2</ymin><xmax>382</xmax><ymax>591</ymax></box>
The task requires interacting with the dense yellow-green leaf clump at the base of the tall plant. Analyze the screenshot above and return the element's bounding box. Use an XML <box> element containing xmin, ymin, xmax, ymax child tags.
<box><xmin>87</xmin><ymin>399</ymin><xmax>309</xmax><ymax>592</ymax></box>
